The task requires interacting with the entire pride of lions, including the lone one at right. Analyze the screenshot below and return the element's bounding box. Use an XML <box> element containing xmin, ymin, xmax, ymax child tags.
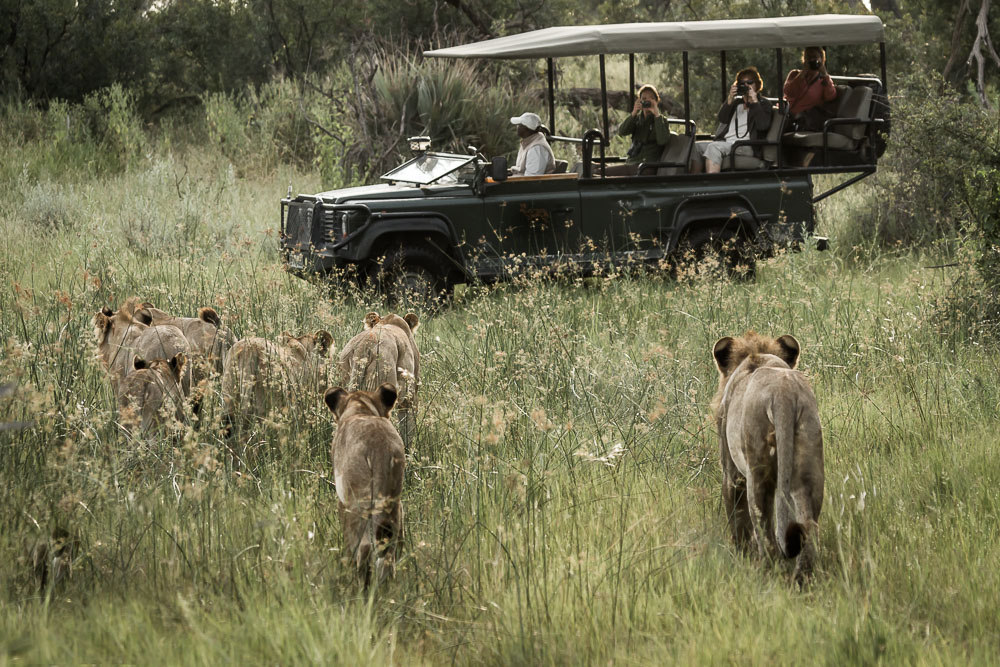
<box><xmin>94</xmin><ymin>298</ymin><xmax>824</xmax><ymax>584</ymax></box>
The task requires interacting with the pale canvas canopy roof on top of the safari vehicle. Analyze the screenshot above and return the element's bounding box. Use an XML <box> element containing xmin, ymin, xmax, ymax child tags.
<box><xmin>424</xmin><ymin>14</ymin><xmax>885</xmax><ymax>59</ymax></box>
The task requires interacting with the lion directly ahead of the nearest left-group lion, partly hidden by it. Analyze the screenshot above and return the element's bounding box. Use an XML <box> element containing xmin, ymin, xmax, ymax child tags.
<box><xmin>337</xmin><ymin>312</ymin><xmax>420</xmax><ymax>444</ymax></box>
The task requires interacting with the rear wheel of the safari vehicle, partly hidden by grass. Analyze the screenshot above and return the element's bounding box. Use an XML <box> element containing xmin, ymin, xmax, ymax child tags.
<box><xmin>672</xmin><ymin>229</ymin><xmax>757</xmax><ymax>280</ymax></box>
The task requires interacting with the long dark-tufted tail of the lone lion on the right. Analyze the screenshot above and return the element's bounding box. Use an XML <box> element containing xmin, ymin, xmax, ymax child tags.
<box><xmin>770</xmin><ymin>400</ymin><xmax>806</xmax><ymax>558</ymax></box>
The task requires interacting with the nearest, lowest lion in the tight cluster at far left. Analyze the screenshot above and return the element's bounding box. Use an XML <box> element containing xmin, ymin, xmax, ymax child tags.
<box><xmin>118</xmin><ymin>352</ymin><xmax>186</xmax><ymax>433</ymax></box>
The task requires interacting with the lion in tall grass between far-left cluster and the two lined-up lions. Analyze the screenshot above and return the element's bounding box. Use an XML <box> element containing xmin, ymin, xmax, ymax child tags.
<box><xmin>222</xmin><ymin>331</ymin><xmax>333</xmax><ymax>434</ymax></box>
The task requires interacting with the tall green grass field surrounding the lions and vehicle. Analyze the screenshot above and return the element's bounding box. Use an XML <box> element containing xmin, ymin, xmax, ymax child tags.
<box><xmin>0</xmin><ymin>150</ymin><xmax>1000</xmax><ymax>665</ymax></box>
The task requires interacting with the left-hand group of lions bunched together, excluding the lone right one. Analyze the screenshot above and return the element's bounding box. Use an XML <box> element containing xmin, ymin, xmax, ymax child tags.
<box><xmin>94</xmin><ymin>297</ymin><xmax>420</xmax><ymax>582</ymax></box>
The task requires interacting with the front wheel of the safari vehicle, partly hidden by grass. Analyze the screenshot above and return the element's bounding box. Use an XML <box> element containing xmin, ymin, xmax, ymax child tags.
<box><xmin>370</xmin><ymin>245</ymin><xmax>451</xmax><ymax>308</ymax></box>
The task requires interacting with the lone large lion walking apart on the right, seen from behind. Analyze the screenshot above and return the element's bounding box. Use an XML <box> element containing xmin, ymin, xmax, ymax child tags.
<box><xmin>712</xmin><ymin>331</ymin><xmax>823</xmax><ymax>583</ymax></box>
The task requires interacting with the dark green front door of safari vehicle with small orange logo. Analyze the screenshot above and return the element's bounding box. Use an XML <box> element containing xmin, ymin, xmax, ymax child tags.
<box><xmin>484</xmin><ymin>179</ymin><xmax>581</xmax><ymax>263</ymax></box>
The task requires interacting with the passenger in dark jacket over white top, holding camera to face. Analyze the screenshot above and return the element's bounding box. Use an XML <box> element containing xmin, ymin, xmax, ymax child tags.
<box><xmin>690</xmin><ymin>67</ymin><xmax>774</xmax><ymax>174</ymax></box>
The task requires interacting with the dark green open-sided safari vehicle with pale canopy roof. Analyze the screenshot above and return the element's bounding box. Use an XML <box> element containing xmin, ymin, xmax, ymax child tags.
<box><xmin>280</xmin><ymin>15</ymin><xmax>888</xmax><ymax>300</ymax></box>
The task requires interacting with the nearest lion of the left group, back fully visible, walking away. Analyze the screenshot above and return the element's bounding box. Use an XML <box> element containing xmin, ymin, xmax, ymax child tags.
<box><xmin>323</xmin><ymin>384</ymin><xmax>406</xmax><ymax>587</ymax></box>
